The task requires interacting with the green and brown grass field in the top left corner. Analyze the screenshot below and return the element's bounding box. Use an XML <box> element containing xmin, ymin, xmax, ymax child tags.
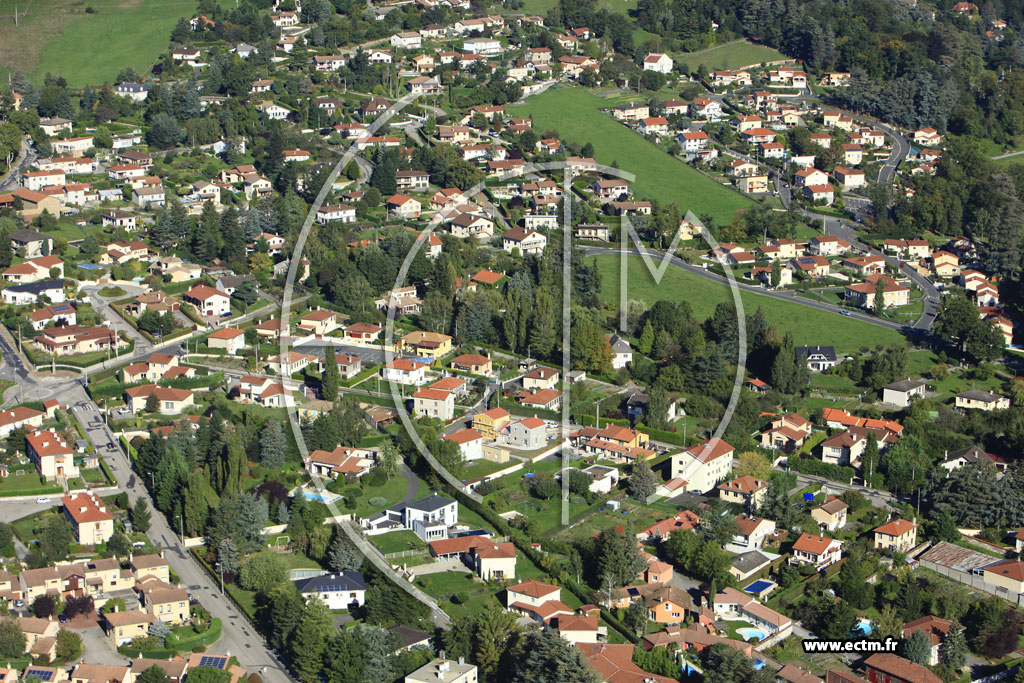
<box><xmin>0</xmin><ymin>0</ymin><xmax>188</xmax><ymax>87</ymax></box>
